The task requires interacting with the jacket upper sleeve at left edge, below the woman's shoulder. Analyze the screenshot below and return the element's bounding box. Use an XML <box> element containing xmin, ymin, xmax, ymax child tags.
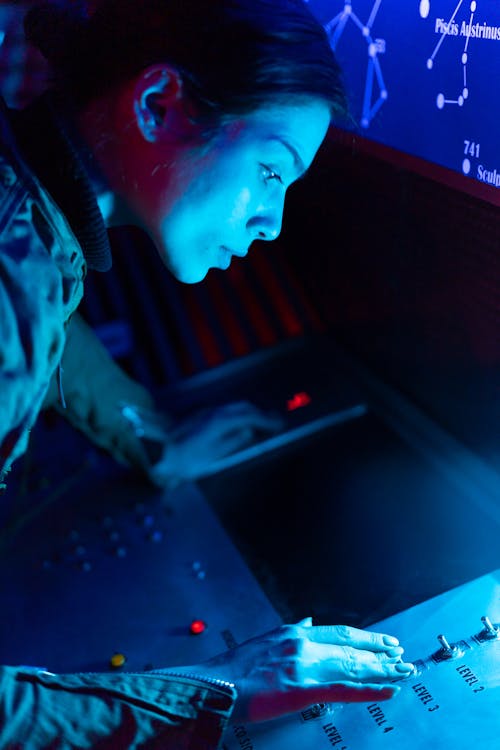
<box><xmin>0</xmin><ymin>182</ymin><xmax>81</xmax><ymax>483</ymax></box>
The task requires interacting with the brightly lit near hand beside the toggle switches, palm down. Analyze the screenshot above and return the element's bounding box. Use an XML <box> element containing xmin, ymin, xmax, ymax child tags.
<box><xmin>166</xmin><ymin>618</ymin><xmax>413</xmax><ymax>722</ymax></box>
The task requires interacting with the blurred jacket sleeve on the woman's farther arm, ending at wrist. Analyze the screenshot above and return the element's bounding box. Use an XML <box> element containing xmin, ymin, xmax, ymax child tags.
<box><xmin>44</xmin><ymin>314</ymin><xmax>160</xmax><ymax>469</ymax></box>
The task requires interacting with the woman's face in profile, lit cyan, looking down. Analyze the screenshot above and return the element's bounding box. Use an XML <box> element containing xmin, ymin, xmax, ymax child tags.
<box><xmin>110</xmin><ymin>99</ymin><xmax>330</xmax><ymax>283</ymax></box>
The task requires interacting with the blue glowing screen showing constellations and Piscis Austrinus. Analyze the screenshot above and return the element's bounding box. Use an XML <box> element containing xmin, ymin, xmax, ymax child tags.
<box><xmin>308</xmin><ymin>0</ymin><xmax>500</xmax><ymax>194</ymax></box>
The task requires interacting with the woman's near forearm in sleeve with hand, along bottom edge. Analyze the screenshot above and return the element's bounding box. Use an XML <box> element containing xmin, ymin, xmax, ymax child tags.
<box><xmin>0</xmin><ymin>618</ymin><xmax>413</xmax><ymax>750</ymax></box>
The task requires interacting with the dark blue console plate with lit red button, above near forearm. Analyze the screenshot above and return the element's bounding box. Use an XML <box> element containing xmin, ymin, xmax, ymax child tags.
<box><xmin>0</xmin><ymin>478</ymin><xmax>281</xmax><ymax>672</ymax></box>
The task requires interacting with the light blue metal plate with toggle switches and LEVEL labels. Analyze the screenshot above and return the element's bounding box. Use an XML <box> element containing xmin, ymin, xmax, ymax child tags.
<box><xmin>225</xmin><ymin>570</ymin><xmax>500</xmax><ymax>750</ymax></box>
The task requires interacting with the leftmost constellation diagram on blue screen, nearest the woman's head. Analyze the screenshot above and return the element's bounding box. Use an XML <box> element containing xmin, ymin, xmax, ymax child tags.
<box><xmin>325</xmin><ymin>0</ymin><xmax>388</xmax><ymax>128</ymax></box>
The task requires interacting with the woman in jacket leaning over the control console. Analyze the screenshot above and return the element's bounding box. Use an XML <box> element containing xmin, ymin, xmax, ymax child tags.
<box><xmin>0</xmin><ymin>0</ymin><xmax>412</xmax><ymax>750</ymax></box>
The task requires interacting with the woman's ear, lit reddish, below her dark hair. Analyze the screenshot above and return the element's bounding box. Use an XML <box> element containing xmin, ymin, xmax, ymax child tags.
<box><xmin>134</xmin><ymin>65</ymin><xmax>182</xmax><ymax>143</ymax></box>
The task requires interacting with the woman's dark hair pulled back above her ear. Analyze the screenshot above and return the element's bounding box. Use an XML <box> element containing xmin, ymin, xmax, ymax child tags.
<box><xmin>25</xmin><ymin>0</ymin><xmax>347</xmax><ymax>121</ymax></box>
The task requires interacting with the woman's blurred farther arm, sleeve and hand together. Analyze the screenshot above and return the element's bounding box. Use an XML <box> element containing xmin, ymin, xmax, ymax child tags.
<box><xmin>44</xmin><ymin>314</ymin><xmax>282</xmax><ymax>486</ymax></box>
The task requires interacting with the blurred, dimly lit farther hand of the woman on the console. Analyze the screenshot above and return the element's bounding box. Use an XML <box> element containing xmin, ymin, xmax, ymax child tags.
<box><xmin>150</xmin><ymin>402</ymin><xmax>283</xmax><ymax>486</ymax></box>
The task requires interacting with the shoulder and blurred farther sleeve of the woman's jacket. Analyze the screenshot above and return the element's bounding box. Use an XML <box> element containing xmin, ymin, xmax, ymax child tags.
<box><xmin>0</xmin><ymin>94</ymin><xmax>152</xmax><ymax>490</ymax></box>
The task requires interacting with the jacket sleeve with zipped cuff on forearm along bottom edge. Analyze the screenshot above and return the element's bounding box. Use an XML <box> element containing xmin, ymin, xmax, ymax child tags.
<box><xmin>0</xmin><ymin>667</ymin><xmax>236</xmax><ymax>750</ymax></box>
